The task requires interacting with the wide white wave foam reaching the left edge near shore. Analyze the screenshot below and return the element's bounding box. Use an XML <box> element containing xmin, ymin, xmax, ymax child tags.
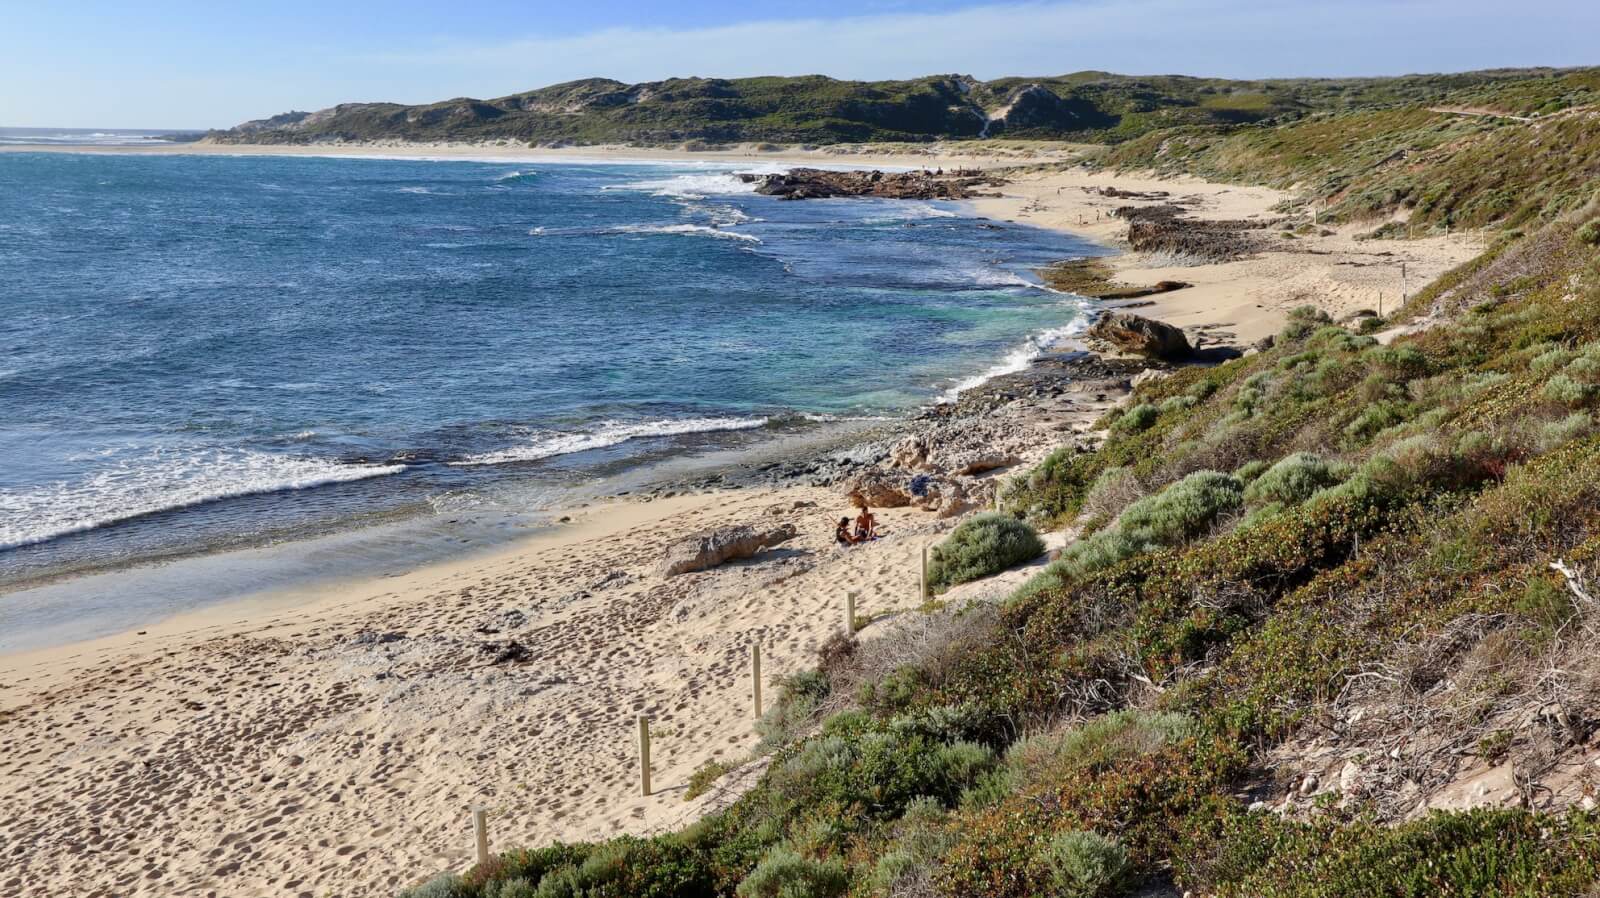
<box><xmin>0</xmin><ymin>448</ymin><xmax>405</xmax><ymax>549</ymax></box>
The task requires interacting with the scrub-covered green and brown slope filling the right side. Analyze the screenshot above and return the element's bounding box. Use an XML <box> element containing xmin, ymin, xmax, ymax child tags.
<box><xmin>393</xmin><ymin>72</ymin><xmax>1600</xmax><ymax>898</ymax></box>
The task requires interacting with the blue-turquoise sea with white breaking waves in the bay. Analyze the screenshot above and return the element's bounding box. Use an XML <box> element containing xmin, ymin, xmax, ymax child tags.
<box><xmin>0</xmin><ymin>154</ymin><xmax>1094</xmax><ymax>584</ymax></box>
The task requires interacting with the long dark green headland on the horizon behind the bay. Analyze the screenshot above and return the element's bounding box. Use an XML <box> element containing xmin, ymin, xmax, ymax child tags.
<box><xmin>211</xmin><ymin>69</ymin><xmax>1587</xmax><ymax>144</ymax></box>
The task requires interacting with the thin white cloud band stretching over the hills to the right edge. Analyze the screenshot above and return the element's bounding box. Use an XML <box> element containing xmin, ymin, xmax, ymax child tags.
<box><xmin>370</xmin><ymin>0</ymin><xmax>1600</xmax><ymax>98</ymax></box>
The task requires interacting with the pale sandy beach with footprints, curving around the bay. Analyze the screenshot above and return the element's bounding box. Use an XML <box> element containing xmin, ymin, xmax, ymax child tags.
<box><xmin>0</xmin><ymin>144</ymin><xmax>1480</xmax><ymax>898</ymax></box>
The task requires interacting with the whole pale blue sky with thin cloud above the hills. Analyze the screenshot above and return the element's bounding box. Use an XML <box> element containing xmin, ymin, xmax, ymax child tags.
<box><xmin>9</xmin><ymin>0</ymin><xmax>1600</xmax><ymax>128</ymax></box>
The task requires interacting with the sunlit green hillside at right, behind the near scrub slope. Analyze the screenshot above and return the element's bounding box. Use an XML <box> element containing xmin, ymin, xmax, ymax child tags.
<box><xmin>1102</xmin><ymin>69</ymin><xmax>1600</xmax><ymax>234</ymax></box>
